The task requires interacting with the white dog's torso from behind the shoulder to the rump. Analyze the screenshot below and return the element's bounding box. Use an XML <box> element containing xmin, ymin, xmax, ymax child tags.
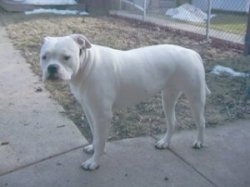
<box><xmin>93</xmin><ymin>45</ymin><xmax>205</xmax><ymax>106</ymax></box>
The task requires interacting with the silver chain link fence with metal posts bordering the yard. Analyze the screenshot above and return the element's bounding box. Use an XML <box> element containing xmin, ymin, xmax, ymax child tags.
<box><xmin>110</xmin><ymin>0</ymin><xmax>250</xmax><ymax>44</ymax></box>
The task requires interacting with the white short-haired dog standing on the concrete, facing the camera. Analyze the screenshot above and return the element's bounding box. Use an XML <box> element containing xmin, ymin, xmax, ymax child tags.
<box><xmin>40</xmin><ymin>34</ymin><xmax>210</xmax><ymax>170</ymax></box>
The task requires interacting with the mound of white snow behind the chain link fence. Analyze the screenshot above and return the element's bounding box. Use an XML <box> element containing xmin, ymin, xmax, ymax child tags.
<box><xmin>166</xmin><ymin>3</ymin><xmax>215</xmax><ymax>23</ymax></box>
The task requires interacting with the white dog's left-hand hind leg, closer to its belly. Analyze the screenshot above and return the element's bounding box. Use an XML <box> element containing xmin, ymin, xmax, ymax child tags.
<box><xmin>155</xmin><ymin>89</ymin><xmax>181</xmax><ymax>149</ymax></box>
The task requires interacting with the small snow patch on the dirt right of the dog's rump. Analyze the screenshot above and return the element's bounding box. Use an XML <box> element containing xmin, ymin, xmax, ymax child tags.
<box><xmin>211</xmin><ymin>65</ymin><xmax>249</xmax><ymax>77</ymax></box>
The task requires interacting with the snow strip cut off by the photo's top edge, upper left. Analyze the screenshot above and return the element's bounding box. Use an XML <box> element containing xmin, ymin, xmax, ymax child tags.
<box><xmin>15</xmin><ymin>0</ymin><xmax>77</xmax><ymax>5</ymax></box>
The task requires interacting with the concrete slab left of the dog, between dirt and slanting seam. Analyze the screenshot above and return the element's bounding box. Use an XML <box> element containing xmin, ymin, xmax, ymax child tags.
<box><xmin>0</xmin><ymin>28</ymin><xmax>87</xmax><ymax>175</ymax></box>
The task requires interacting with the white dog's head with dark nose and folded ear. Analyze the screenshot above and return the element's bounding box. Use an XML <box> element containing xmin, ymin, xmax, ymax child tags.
<box><xmin>40</xmin><ymin>34</ymin><xmax>91</xmax><ymax>81</ymax></box>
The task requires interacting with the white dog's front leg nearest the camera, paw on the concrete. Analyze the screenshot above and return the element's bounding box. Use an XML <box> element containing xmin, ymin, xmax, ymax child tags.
<box><xmin>82</xmin><ymin>107</ymin><xmax>112</xmax><ymax>170</ymax></box>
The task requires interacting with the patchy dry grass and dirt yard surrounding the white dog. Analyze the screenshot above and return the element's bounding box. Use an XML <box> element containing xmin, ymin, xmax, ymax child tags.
<box><xmin>1</xmin><ymin>14</ymin><xmax>250</xmax><ymax>140</ymax></box>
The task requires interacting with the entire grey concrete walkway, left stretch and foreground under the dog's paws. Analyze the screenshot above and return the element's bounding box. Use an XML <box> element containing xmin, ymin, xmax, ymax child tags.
<box><xmin>0</xmin><ymin>25</ymin><xmax>250</xmax><ymax>187</ymax></box>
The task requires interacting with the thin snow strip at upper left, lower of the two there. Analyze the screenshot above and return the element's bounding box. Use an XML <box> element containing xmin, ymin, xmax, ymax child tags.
<box><xmin>25</xmin><ymin>8</ymin><xmax>89</xmax><ymax>15</ymax></box>
